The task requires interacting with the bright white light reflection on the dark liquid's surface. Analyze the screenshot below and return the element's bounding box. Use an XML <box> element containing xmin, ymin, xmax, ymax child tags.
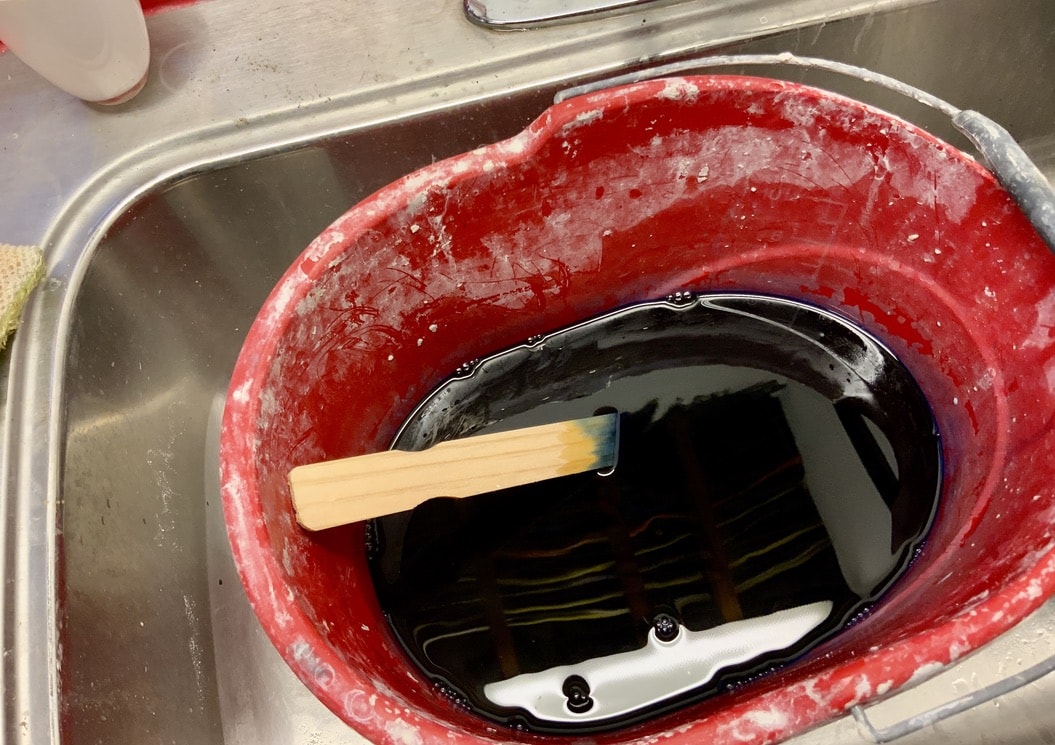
<box><xmin>483</xmin><ymin>600</ymin><xmax>832</xmax><ymax>724</ymax></box>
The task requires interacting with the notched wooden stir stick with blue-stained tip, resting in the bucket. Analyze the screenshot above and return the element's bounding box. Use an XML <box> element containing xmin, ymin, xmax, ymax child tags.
<box><xmin>289</xmin><ymin>414</ymin><xmax>619</xmax><ymax>531</ymax></box>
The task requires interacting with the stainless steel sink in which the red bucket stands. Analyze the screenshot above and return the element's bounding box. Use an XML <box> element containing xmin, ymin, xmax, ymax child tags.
<box><xmin>6</xmin><ymin>0</ymin><xmax>1055</xmax><ymax>744</ymax></box>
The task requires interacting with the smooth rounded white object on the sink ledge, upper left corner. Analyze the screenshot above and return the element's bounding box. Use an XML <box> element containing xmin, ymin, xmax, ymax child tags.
<box><xmin>0</xmin><ymin>0</ymin><xmax>150</xmax><ymax>103</ymax></box>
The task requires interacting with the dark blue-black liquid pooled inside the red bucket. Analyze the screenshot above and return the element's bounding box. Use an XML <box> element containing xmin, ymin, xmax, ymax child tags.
<box><xmin>370</xmin><ymin>295</ymin><xmax>941</xmax><ymax>733</ymax></box>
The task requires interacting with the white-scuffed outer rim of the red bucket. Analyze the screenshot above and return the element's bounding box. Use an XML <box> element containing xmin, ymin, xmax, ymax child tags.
<box><xmin>220</xmin><ymin>74</ymin><xmax>1055</xmax><ymax>743</ymax></box>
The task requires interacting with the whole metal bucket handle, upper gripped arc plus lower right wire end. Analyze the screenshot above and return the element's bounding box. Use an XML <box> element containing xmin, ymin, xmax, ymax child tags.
<box><xmin>554</xmin><ymin>53</ymin><xmax>1055</xmax><ymax>743</ymax></box>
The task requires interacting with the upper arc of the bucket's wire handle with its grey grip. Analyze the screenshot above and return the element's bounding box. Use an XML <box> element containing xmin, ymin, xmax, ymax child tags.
<box><xmin>554</xmin><ymin>52</ymin><xmax>1055</xmax><ymax>252</ymax></box>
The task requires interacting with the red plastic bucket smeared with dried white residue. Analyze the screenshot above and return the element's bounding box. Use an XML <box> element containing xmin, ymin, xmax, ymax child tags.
<box><xmin>222</xmin><ymin>76</ymin><xmax>1055</xmax><ymax>744</ymax></box>
